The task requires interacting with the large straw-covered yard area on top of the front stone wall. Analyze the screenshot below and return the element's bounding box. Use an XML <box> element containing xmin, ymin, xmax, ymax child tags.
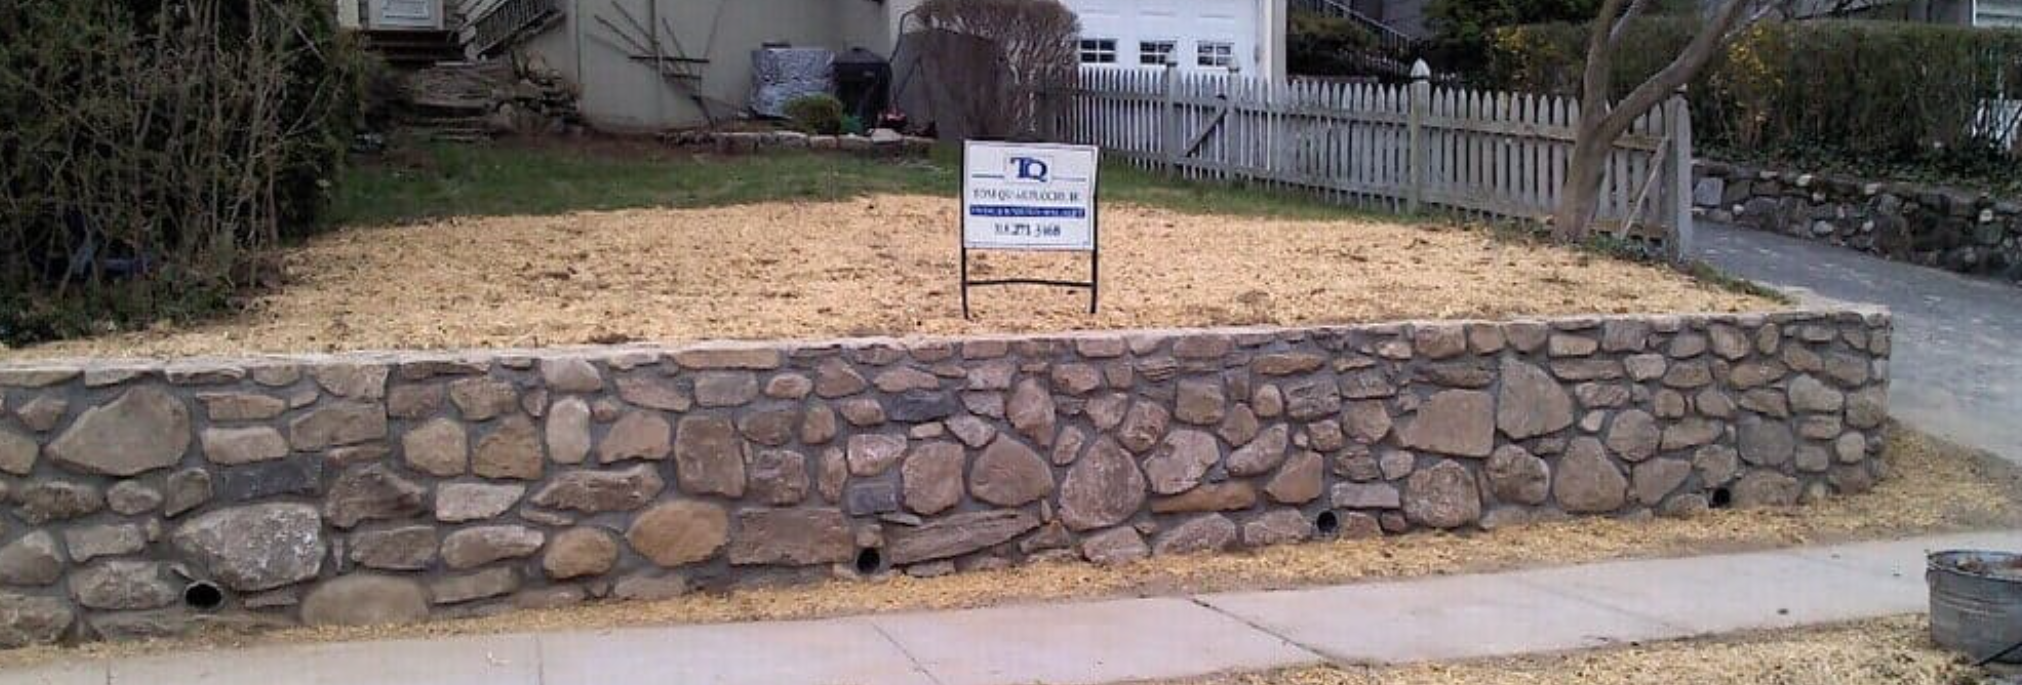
<box><xmin>0</xmin><ymin>196</ymin><xmax>1777</xmax><ymax>358</ymax></box>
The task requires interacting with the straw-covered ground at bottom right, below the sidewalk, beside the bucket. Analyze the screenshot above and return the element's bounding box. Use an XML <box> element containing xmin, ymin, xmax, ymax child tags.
<box><xmin>1167</xmin><ymin>616</ymin><xmax>1982</xmax><ymax>685</ymax></box>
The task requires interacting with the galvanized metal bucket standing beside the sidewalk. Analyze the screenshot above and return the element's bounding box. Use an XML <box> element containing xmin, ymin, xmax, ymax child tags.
<box><xmin>1923</xmin><ymin>550</ymin><xmax>2022</xmax><ymax>663</ymax></box>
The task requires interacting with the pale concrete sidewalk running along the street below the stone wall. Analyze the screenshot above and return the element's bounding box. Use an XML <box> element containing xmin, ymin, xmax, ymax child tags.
<box><xmin>0</xmin><ymin>531</ymin><xmax>2022</xmax><ymax>685</ymax></box>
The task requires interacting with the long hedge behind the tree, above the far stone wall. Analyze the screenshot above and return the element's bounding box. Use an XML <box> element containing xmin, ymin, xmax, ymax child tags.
<box><xmin>1470</xmin><ymin>18</ymin><xmax>2022</xmax><ymax>182</ymax></box>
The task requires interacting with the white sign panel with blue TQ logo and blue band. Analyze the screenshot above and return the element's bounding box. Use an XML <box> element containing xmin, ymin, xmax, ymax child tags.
<box><xmin>962</xmin><ymin>141</ymin><xmax>1100</xmax><ymax>253</ymax></box>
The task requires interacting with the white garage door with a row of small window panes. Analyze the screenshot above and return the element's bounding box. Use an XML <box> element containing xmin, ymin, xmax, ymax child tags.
<box><xmin>1068</xmin><ymin>0</ymin><xmax>1258</xmax><ymax>71</ymax></box>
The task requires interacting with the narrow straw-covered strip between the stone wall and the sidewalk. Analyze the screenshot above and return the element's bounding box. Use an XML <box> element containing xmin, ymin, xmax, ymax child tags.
<box><xmin>0</xmin><ymin>428</ymin><xmax>2022</xmax><ymax>683</ymax></box>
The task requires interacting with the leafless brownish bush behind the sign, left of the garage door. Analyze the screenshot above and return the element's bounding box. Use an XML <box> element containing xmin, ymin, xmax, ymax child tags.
<box><xmin>914</xmin><ymin>0</ymin><xmax>1082</xmax><ymax>135</ymax></box>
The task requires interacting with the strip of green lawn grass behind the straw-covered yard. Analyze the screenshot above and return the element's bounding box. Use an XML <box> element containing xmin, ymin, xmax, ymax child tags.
<box><xmin>326</xmin><ymin>141</ymin><xmax>1397</xmax><ymax>226</ymax></box>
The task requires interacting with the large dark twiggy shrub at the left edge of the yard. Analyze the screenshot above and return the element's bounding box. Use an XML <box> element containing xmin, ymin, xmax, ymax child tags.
<box><xmin>0</xmin><ymin>0</ymin><xmax>368</xmax><ymax>346</ymax></box>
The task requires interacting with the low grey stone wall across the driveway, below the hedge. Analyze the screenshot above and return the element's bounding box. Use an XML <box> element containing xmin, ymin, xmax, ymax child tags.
<box><xmin>1692</xmin><ymin>162</ymin><xmax>2022</xmax><ymax>283</ymax></box>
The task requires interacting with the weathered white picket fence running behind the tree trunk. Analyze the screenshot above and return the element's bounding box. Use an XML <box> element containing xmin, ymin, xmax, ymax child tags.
<box><xmin>1049</xmin><ymin>67</ymin><xmax>1692</xmax><ymax>253</ymax></box>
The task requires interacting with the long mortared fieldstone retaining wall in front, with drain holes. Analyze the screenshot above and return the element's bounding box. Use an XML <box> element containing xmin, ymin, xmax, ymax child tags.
<box><xmin>0</xmin><ymin>311</ymin><xmax>1891</xmax><ymax>645</ymax></box>
